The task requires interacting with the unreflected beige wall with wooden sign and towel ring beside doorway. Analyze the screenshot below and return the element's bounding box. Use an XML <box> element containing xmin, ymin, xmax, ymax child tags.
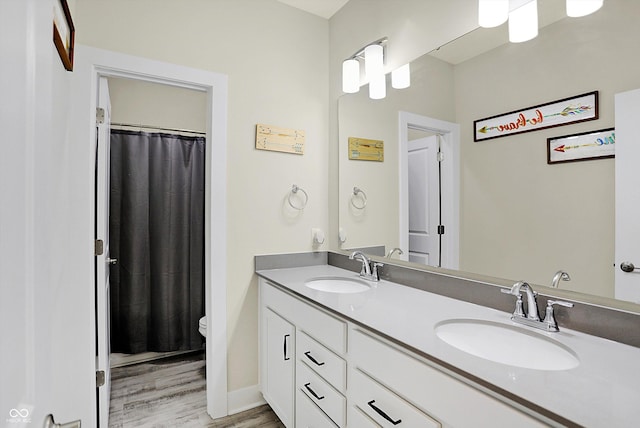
<box><xmin>74</xmin><ymin>0</ymin><xmax>329</xmax><ymax>391</ymax></box>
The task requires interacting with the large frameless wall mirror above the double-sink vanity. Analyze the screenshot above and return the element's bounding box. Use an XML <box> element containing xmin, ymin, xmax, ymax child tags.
<box><xmin>338</xmin><ymin>0</ymin><xmax>640</xmax><ymax>308</ymax></box>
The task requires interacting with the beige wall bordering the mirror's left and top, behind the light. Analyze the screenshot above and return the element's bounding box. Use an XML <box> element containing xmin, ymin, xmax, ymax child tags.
<box><xmin>327</xmin><ymin>0</ymin><xmax>478</xmax><ymax>248</ymax></box>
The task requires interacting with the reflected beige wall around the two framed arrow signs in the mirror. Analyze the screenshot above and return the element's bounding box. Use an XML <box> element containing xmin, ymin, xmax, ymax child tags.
<box><xmin>455</xmin><ymin>0</ymin><xmax>640</xmax><ymax>297</ymax></box>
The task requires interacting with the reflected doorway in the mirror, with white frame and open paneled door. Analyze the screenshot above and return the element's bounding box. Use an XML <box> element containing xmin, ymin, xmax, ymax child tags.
<box><xmin>398</xmin><ymin>111</ymin><xmax>460</xmax><ymax>269</ymax></box>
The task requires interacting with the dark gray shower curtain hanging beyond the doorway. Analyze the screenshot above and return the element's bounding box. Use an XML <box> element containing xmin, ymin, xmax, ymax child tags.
<box><xmin>109</xmin><ymin>130</ymin><xmax>205</xmax><ymax>353</ymax></box>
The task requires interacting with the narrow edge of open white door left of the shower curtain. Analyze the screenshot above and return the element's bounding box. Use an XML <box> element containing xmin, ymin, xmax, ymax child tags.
<box><xmin>95</xmin><ymin>77</ymin><xmax>116</xmax><ymax>428</ymax></box>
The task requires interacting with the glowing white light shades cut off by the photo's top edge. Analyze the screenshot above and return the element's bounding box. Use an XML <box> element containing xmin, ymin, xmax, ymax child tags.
<box><xmin>478</xmin><ymin>0</ymin><xmax>604</xmax><ymax>43</ymax></box>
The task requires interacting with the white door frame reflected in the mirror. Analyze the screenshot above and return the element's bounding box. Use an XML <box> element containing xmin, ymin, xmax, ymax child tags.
<box><xmin>398</xmin><ymin>111</ymin><xmax>460</xmax><ymax>269</ymax></box>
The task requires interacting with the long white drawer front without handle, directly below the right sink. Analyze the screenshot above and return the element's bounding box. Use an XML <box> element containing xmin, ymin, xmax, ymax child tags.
<box><xmin>349</xmin><ymin>329</ymin><xmax>546</xmax><ymax>427</ymax></box>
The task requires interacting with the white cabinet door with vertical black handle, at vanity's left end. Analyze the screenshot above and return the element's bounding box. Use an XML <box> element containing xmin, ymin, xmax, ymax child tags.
<box><xmin>262</xmin><ymin>308</ymin><xmax>295</xmax><ymax>428</ymax></box>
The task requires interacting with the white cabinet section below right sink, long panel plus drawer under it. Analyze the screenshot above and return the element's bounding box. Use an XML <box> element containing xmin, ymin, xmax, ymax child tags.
<box><xmin>347</xmin><ymin>328</ymin><xmax>546</xmax><ymax>428</ymax></box>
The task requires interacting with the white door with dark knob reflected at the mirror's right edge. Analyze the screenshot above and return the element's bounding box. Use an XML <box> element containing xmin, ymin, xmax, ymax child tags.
<box><xmin>615</xmin><ymin>89</ymin><xmax>640</xmax><ymax>303</ymax></box>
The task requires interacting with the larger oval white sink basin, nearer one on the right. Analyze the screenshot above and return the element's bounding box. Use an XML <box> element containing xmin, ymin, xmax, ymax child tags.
<box><xmin>435</xmin><ymin>319</ymin><xmax>580</xmax><ymax>370</ymax></box>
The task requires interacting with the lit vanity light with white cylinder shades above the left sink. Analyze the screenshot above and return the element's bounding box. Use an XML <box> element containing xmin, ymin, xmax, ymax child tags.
<box><xmin>342</xmin><ymin>37</ymin><xmax>411</xmax><ymax>100</ymax></box>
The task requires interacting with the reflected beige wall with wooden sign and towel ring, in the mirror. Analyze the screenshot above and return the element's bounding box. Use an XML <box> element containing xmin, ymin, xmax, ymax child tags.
<box><xmin>338</xmin><ymin>55</ymin><xmax>455</xmax><ymax>251</ymax></box>
